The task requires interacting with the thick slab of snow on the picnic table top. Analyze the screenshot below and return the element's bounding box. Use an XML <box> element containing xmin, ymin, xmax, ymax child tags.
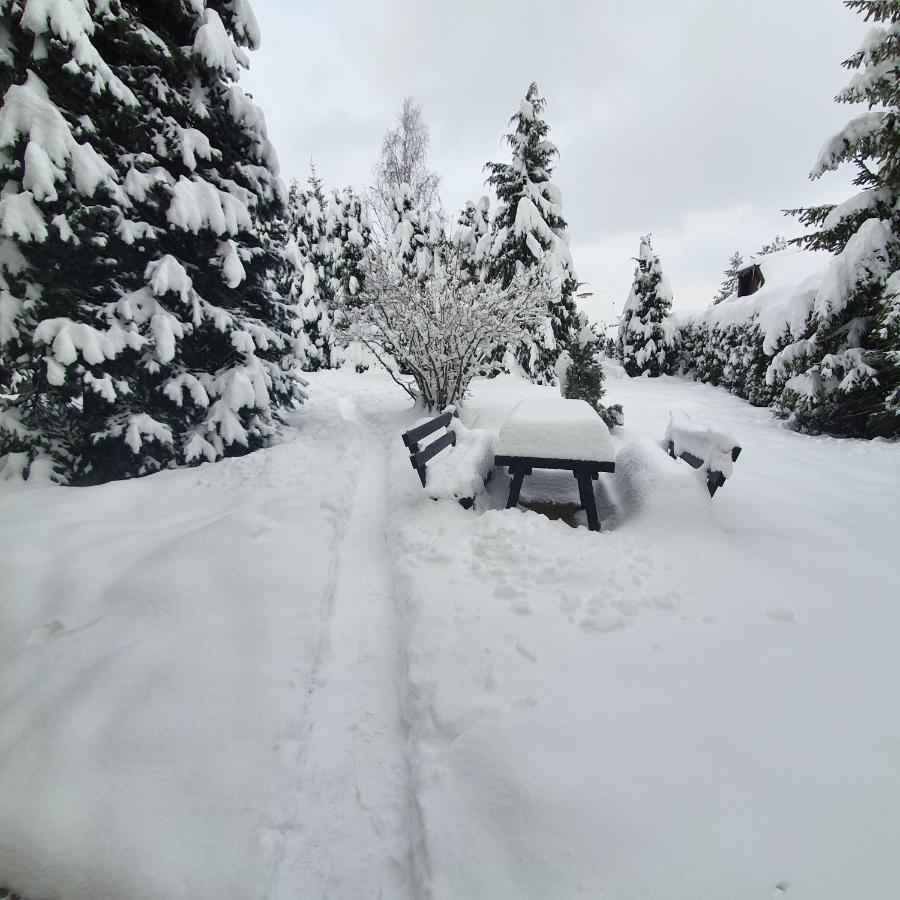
<box><xmin>496</xmin><ymin>397</ymin><xmax>616</xmax><ymax>462</ymax></box>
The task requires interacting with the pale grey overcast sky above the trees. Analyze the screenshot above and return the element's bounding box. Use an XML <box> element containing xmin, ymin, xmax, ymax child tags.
<box><xmin>245</xmin><ymin>0</ymin><xmax>866</xmax><ymax>319</ymax></box>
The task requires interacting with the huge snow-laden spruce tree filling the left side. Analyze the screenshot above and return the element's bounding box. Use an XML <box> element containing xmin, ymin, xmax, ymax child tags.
<box><xmin>0</xmin><ymin>0</ymin><xmax>302</xmax><ymax>480</ymax></box>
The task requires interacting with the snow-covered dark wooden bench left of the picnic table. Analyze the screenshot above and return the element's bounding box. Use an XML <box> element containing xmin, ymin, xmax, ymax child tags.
<box><xmin>403</xmin><ymin>407</ymin><xmax>494</xmax><ymax>509</ymax></box>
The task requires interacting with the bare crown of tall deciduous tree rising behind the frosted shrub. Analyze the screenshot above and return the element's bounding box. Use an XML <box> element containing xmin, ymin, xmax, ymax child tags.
<box><xmin>369</xmin><ymin>97</ymin><xmax>441</xmax><ymax>239</ymax></box>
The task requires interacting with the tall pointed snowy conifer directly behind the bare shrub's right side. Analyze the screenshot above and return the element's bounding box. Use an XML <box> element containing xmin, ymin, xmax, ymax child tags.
<box><xmin>485</xmin><ymin>83</ymin><xmax>578</xmax><ymax>384</ymax></box>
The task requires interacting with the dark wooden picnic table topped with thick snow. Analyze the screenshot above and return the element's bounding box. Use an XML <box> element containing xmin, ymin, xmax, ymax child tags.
<box><xmin>494</xmin><ymin>397</ymin><xmax>616</xmax><ymax>531</ymax></box>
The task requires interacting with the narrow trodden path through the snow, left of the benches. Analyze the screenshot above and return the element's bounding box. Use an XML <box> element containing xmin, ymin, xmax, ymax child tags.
<box><xmin>271</xmin><ymin>397</ymin><xmax>412</xmax><ymax>900</ymax></box>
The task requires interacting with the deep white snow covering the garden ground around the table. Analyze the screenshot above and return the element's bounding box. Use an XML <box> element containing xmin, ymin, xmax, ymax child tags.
<box><xmin>0</xmin><ymin>369</ymin><xmax>900</xmax><ymax>900</ymax></box>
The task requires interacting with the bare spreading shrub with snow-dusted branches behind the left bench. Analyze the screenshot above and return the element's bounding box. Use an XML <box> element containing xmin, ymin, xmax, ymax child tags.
<box><xmin>338</xmin><ymin>243</ymin><xmax>547</xmax><ymax>411</ymax></box>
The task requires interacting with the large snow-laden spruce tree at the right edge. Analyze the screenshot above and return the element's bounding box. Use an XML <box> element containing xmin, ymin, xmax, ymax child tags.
<box><xmin>770</xmin><ymin>0</ymin><xmax>900</xmax><ymax>437</ymax></box>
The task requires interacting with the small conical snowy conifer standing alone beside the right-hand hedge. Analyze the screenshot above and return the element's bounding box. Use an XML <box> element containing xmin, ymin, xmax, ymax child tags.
<box><xmin>619</xmin><ymin>235</ymin><xmax>675</xmax><ymax>378</ymax></box>
